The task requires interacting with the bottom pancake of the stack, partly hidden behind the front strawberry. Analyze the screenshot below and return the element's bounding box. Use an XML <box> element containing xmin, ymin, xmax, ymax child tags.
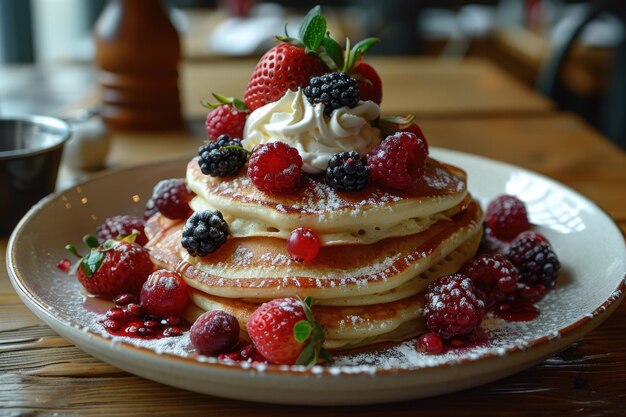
<box><xmin>185</xmin><ymin>290</ymin><xmax>425</xmax><ymax>349</ymax></box>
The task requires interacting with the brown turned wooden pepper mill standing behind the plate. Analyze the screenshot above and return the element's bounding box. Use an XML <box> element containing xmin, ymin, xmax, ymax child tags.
<box><xmin>95</xmin><ymin>0</ymin><xmax>182</xmax><ymax>130</ymax></box>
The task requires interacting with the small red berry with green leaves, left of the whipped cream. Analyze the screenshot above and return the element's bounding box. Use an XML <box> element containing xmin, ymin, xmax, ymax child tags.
<box><xmin>204</xmin><ymin>94</ymin><xmax>250</xmax><ymax>141</ymax></box>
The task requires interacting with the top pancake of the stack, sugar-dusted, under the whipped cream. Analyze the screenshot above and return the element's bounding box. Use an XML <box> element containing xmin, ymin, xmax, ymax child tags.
<box><xmin>186</xmin><ymin>159</ymin><xmax>467</xmax><ymax>246</ymax></box>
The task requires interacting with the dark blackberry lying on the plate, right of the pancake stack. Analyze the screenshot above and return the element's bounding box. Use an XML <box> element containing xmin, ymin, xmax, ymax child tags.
<box><xmin>506</xmin><ymin>237</ymin><xmax>561</xmax><ymax>288</ymax></box>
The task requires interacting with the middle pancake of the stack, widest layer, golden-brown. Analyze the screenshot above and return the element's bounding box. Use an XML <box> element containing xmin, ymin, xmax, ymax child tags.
<box><xmin>146</xmin><ymin>197</ymin><xmax>482</xmax><ymax>300</ymax></box>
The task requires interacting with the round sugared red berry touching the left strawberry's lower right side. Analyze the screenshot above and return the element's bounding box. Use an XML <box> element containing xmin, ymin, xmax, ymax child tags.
<box><xmin>140</xmin><ymin>269</ymin><xmax>188</xmax><ymax>317</ymax></box>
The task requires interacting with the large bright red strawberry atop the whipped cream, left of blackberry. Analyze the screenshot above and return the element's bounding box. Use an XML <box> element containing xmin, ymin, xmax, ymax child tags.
<box><xmin>244</xmin><ymin>42</ymin><xmax>324</xmax><ymax>110</ymax></box>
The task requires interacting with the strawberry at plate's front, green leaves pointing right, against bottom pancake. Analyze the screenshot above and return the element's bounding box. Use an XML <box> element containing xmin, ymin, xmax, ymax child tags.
<box><xmin>246</xmin><ymin>297</ymin><xmax>329</xmax><ymax>366</ymax></box>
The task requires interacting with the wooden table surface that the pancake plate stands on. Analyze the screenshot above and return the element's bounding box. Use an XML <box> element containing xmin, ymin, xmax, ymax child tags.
<box><xmin>0</xmin><ymin>56</ymin><xmax>626</xmax><ymax>417</ymax></box>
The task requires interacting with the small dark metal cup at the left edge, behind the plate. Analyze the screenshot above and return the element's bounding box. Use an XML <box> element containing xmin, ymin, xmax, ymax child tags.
<box><xmin>0</xmin><ymin>116</ymin><xmax>71</xmax><ymax>235</ymax></box>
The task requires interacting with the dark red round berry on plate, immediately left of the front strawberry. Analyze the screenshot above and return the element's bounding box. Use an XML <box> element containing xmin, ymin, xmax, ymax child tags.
<box><xmin>189</xmin><ymin>310</ymin><xmax>240</xmax><ymax>356</ymax></box>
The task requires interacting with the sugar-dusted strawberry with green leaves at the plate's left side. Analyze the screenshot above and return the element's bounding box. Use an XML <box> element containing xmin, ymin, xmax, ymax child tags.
<box><xmin>67</xmin><ymin>235</ymin><xmax>154</xmax><ymax>299</ymax></box>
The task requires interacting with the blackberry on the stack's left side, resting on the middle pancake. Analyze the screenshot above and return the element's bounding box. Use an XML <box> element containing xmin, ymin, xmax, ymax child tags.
<box><xmin>181</xmin><ymin>210</ymin><xmax>228</xmax><ymax>256</ymax></box>
